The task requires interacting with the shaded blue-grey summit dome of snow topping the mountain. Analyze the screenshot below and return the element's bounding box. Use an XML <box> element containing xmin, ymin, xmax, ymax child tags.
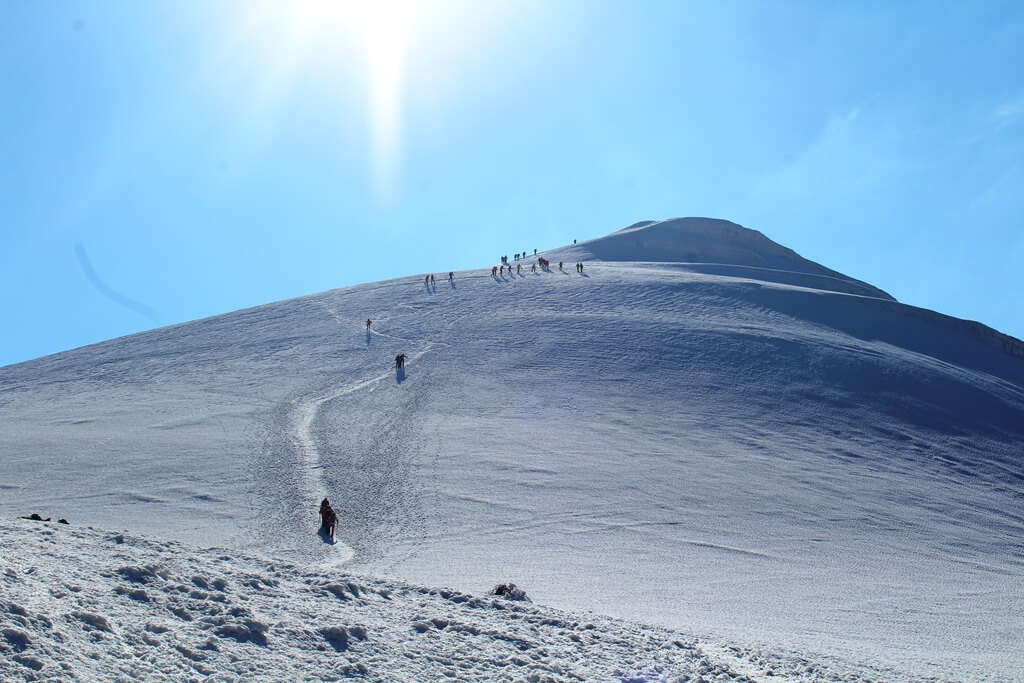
<box><xmin>553</xmin><ymin>218</ymin><xmax>893</xmax><ymax>300</ymax></box>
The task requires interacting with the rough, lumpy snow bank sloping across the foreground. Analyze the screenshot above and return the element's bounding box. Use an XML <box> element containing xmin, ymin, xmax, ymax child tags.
<box><xmin>0</xmin><ymin>520</ymin><xmax>879</xmax><ymax>682</ymax></box>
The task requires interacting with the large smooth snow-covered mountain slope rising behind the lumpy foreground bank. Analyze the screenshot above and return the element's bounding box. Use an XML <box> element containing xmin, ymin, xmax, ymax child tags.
<box><xmin>0</xmin><ymin>218</ymin><xmax>1024</xmax><ymax>680</ymax></box>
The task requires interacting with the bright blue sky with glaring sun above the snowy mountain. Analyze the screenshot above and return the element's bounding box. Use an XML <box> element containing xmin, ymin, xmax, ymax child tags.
<box><xmin>0</xmin><ymin>0</ymin><xmax>1024</xmax><ymax>365</ymax></box>
